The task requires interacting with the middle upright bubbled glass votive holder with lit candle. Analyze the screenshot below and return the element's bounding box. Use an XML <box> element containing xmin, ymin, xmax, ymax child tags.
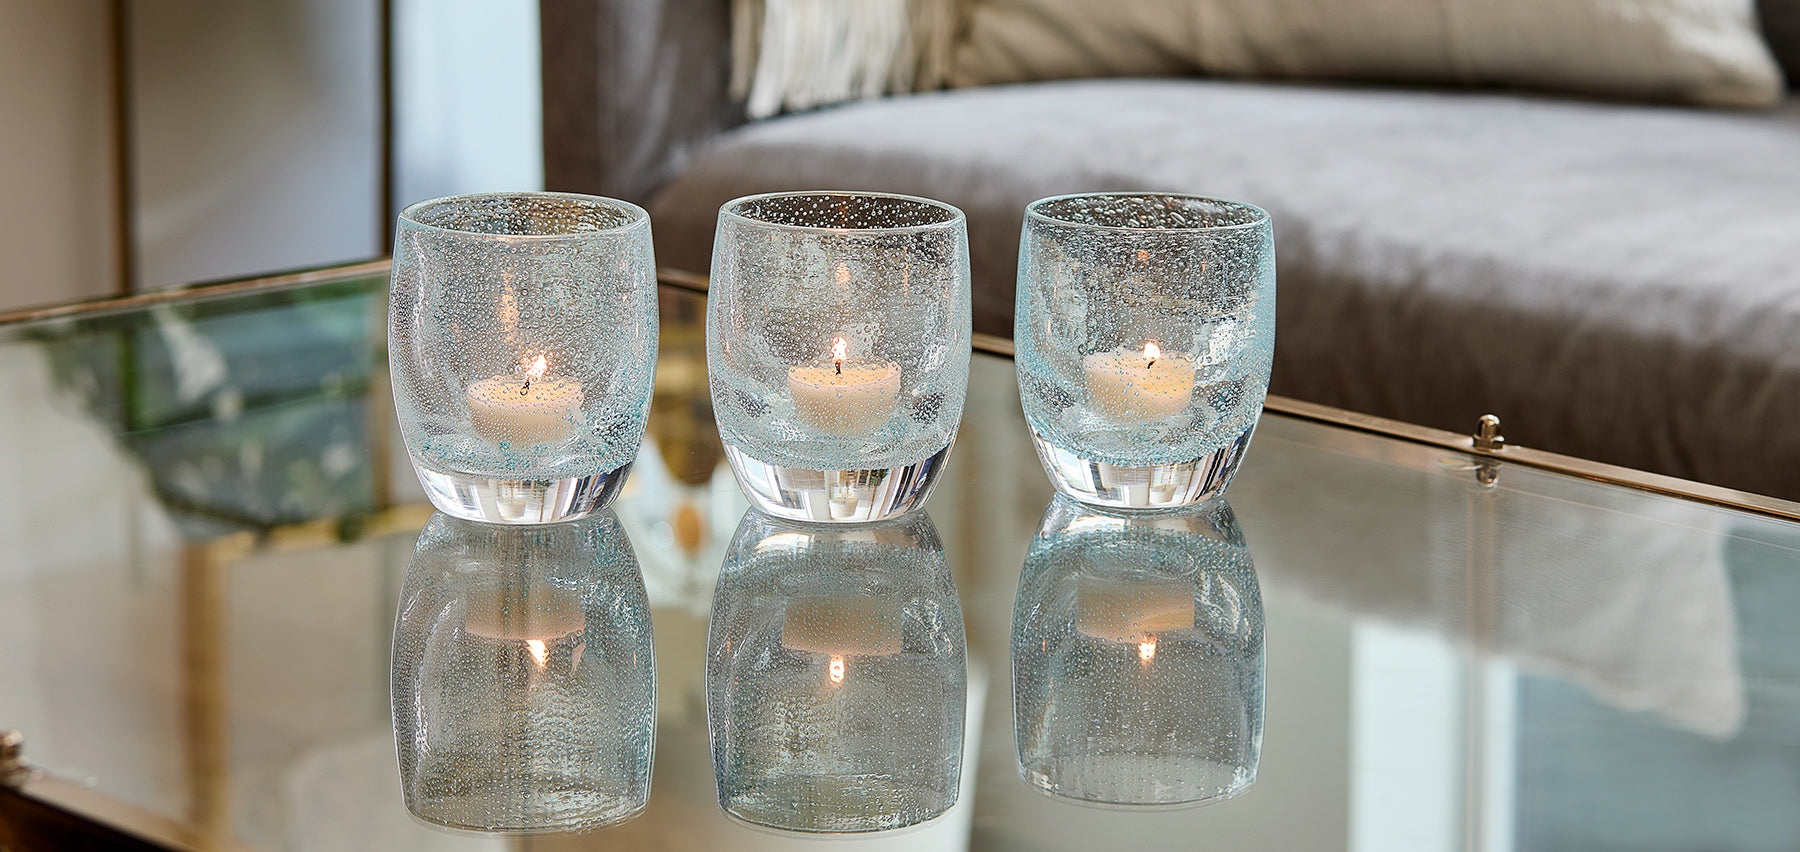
<box><xmin>706</xmin><ymin>193</ymin><xmax>970</xmax><ymax>522</ymax></box>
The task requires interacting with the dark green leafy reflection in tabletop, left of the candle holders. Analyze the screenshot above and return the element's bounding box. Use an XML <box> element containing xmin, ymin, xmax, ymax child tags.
<box><xmin>22</xmin><ymin>276</ymin><xmax>389</xmax><ymax>535</ymax></box>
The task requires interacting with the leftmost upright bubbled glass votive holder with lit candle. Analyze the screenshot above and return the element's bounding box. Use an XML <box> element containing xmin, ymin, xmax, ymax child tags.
<box><xmin>387</xmin><ymin>193</ymin><xmax>657</xmax><ymax>524</ymax></box>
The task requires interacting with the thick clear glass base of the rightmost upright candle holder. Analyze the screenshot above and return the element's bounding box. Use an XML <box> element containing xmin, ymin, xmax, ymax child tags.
<box><xmin>1031</xmin><ymin>425</ymin><xmax>1256</xmax><ymax>510</ymax></box>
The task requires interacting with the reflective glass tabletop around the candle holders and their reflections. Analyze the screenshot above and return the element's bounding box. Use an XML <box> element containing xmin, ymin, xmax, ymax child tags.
<box><xmin>0</xmin><ymin>265</ymin><xmax>1800</xmax><ymax>850</ymax></box>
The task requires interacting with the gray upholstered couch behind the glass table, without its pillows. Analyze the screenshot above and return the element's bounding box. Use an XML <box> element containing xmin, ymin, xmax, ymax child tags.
<box><xmin>542</xmin><ymin>0</ymin><xmax>1800</xmax><ymax>499</ymax></box>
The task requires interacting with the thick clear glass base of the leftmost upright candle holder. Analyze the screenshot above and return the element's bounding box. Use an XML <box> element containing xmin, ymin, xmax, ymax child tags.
<box><xmin>412</xmin><ymin>459</ymin><xmax>632</xmax><ymax>524</ymax></box>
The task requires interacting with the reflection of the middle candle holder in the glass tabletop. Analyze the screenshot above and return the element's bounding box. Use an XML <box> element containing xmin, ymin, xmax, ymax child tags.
<box><xmin>706</xmin><ymin>512</ymin><xmax>968</xmax><ymax>834</ymax></box>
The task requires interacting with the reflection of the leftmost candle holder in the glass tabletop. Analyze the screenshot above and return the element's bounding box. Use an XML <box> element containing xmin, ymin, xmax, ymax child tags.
<box><xmin>389</xmin><ymin>512</ymin><xmax>657</xmax><ymax>834</ymax></box>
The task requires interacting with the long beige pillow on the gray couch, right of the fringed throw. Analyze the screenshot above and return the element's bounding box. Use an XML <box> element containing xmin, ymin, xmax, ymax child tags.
<box><xmin>950</xmin><ymin>0</ymin><xmax>1782</xmax><ymax>106</ymax></box>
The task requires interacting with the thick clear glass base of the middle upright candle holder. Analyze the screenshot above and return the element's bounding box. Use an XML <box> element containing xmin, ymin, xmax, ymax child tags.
<box><xmin>725</xmin><ymin>443</ymin><xmax>950</xmax><ymax>524</ymax></box>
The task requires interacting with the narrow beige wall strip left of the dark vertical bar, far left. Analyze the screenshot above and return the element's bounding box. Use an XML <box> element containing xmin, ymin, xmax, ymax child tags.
<box><xmin>0</xmin><ymin>0</ymin><xmax>113</xmax><ymax>312</ymax></box>
